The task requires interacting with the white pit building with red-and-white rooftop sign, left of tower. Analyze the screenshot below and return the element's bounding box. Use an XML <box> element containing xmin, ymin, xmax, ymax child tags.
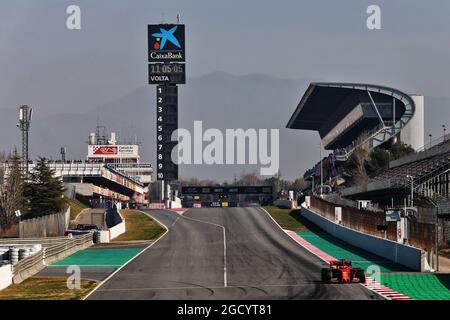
<box><xmin>30</xmin><ymin>127</ymin><xmax>153</xmax><ymax>207</ymax></box>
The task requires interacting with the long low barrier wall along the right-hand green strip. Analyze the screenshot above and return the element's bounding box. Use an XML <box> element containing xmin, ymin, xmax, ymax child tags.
<box><xmin>301</xmin><ymin>207</ymin><xmax>425</xmax><ymax>271</ymax></box>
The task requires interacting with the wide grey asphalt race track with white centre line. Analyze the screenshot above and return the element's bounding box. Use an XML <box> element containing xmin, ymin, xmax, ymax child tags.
<box><xmin>88</xmin><ymin>208</ymin><xmax>379</xmax><ymax>300</ymax></box>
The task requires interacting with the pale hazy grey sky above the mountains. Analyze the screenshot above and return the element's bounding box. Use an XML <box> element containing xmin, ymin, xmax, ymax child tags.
<box><xmin>0</xmin><ymin>0</ymin><xmax>450</xmax><ymax>178</ymax></box>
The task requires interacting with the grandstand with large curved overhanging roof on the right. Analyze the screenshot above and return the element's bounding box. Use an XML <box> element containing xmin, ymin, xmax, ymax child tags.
<box><xmin>287</xmin><ymin>83</ymin><xmax>424</xmax><ymax>161</ymax></box>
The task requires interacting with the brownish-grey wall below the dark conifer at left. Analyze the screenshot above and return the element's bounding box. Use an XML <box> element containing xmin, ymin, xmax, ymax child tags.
<box><xmin>19</xmin><ymin>207</ymin><xmax>70</xmax><ymax>238</ymax></box>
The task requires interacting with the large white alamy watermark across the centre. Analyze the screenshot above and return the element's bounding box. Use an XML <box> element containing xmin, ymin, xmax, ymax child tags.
<box><xmin>171</xmin><ymin>121</ymin><xmax>280</xmax><ymax>176</ymax></box>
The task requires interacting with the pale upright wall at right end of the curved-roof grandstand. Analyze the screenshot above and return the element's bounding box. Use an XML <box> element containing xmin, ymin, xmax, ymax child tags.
<box><xmin>400</xmin><ymin>94</ymin><xmax>425</xmax><ymax>149</ymax></box>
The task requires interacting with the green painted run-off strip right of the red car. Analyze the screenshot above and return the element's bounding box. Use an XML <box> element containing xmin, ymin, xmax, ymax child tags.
<box><xmin>297</xmin><ymin>231</ymin><xmax>450</xmax><ymax>300</ymax></box>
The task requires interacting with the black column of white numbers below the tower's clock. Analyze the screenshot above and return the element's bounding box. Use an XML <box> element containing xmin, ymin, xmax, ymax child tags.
<box><xmin>156</xmin><ymin>86</ymin><xmax>178</xmax><ymax>181</ymax></box>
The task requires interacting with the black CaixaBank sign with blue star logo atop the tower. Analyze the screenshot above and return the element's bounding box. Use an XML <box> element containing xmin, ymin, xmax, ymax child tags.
<box><xmin>148</xmin><ymin>24</ymin><xmax>185</xmax><ymax>62</ymax></box>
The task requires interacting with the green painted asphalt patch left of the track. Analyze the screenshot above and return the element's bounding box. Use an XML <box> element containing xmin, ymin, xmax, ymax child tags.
<box><xmin>51</xmin><ymin>248</ymin><xmax>143</xmax><ymax>268</ymax></box>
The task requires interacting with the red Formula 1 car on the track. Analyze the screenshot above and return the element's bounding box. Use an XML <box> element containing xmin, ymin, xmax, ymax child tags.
<box><xmin>322</xmin><ymin>259</ymin><xmax>366</xmax><ymax>283</ymax></box>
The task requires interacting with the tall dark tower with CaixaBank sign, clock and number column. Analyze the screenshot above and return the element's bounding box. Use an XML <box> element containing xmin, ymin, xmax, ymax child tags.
<box><xmin>148</xmin><ymin>24</ymin><xmax>186</xmax><ymax>200</ymax></box>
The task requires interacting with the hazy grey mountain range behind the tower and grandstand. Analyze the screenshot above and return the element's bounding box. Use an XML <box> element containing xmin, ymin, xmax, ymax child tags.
<box><xmin>0</xmin><ymin>72</ymin><xmax>450</xmax><ymax>181</ymax></box>
